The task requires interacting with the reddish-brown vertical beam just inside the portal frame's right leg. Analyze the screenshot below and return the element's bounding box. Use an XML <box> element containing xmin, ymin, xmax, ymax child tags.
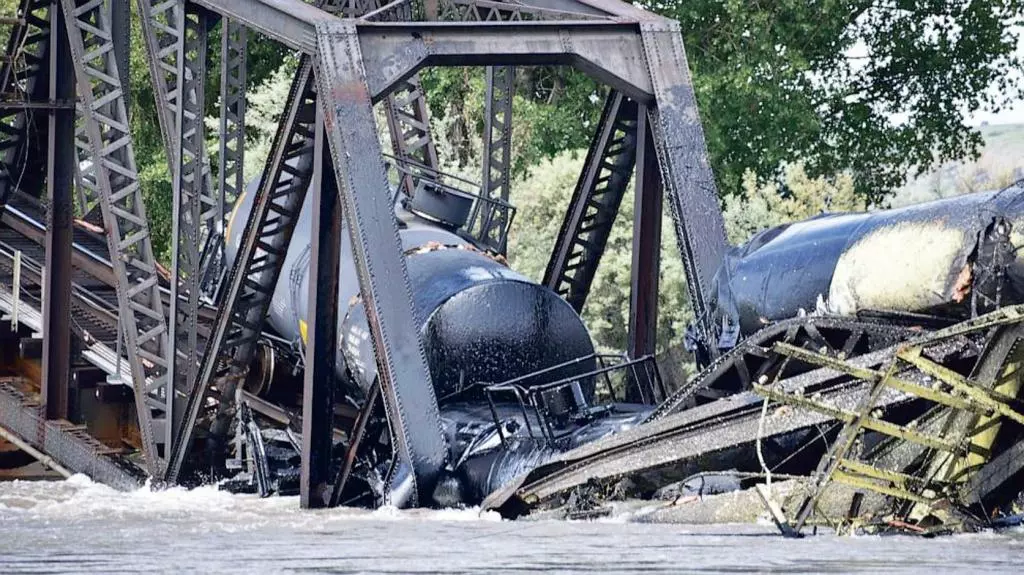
<box><xmin>627</xmin><ymin>105</ymin><xmax>662</xmax><ymax>362</ymax></box>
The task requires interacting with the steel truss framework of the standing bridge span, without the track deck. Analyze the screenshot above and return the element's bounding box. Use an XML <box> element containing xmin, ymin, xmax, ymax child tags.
<box><xmin>0</xmin><ymin>0</ymin><xmax>725</xmax><ymax>499</ymax></box>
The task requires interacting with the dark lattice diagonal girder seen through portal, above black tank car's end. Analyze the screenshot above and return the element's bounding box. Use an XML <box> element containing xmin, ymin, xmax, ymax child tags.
<box><xmin>544</xmin><ymin>91</ymin><xmax>638</xmax><ymax>312</ymax></box>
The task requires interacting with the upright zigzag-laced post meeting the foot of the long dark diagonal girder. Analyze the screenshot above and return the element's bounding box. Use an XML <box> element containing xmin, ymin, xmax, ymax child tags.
<box><xmin>165</xmin><ymin>3</ymin><xmax>209</xmax><ymax>445</ymax></box>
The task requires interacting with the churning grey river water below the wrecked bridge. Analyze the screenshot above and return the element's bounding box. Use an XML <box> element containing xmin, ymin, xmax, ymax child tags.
<box><xmin>0</xmin><ymin>477</ymin><xmax>1024</xmax><ymax>574</ymax></box>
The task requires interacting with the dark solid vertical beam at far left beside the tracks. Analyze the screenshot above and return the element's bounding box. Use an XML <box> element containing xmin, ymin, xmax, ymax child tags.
<box><xmin>41</xmin><ymin>0</ymin><xmax>75</xmax><ymax>419</ymax></box>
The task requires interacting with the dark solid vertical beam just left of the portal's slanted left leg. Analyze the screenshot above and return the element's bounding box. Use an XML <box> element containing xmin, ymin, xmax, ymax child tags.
<box><xmin>299</xmin><ymin>101</ymin><xmax>342</xmax><ymax>508</ymax></box>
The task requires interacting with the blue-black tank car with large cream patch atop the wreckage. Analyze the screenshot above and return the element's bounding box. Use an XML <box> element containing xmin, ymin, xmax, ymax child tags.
<box><xmin>705</xmin><ymin>188</ymin><xmax>1024</xmax><ymax>352</ymax></box>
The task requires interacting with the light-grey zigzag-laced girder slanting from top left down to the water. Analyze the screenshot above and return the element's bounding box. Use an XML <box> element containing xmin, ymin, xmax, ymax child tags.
<box><xmin>61</xmin><ymin>0</ymin><xmax>170</xmax><ymax>477</ymax></box>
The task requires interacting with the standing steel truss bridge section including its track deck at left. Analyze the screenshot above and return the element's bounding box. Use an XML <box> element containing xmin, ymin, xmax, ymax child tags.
<box><xmin>0</xmin><ymin>0</ymin><xmax>726</xmax><ymax>506</ymax></box>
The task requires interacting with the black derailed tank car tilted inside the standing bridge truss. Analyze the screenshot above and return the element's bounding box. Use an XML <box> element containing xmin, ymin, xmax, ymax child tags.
<box><xmin>226</xmin><ymin>179</ymin><xmax>657</xmax><ymax>504</ymax></box>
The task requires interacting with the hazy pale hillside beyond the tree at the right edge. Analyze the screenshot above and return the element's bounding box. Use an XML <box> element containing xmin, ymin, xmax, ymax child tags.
<box><xmin>892</xmin><ymin>124</ymin><xmax>1024</xmax><ymax>208</ymax></box>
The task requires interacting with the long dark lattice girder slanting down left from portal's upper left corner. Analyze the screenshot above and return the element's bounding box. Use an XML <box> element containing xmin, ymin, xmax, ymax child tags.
<box><xmin>165</xmin><ymin>56</ymin><xmax>316</xmax><ymax>482</ymax></box>
